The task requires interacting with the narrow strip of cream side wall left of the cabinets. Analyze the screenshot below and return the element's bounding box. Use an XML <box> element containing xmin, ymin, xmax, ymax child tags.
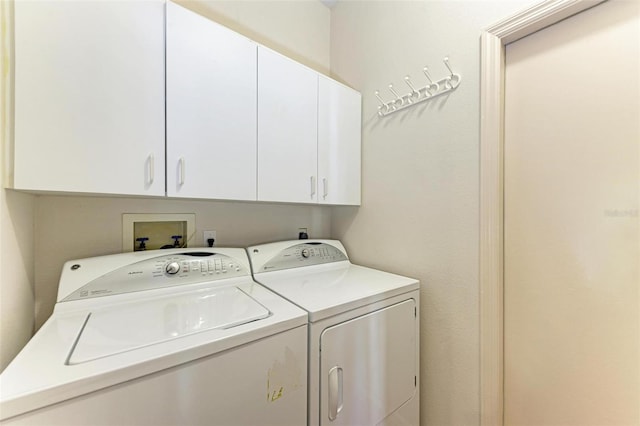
<box><xmin>0</xmin><ymin>2</ymin><xmax>35</xmax><ymax>371</ymax></box>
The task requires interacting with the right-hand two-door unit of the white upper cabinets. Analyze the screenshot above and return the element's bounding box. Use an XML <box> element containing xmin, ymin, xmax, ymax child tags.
<box><xmin>258</xmin><ymin>46</ymin><xmax>361</xmax><ymax>205</ymax></box>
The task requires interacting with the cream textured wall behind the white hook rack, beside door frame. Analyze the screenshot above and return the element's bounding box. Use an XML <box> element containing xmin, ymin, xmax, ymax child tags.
<box><xmin>331</xmin><ymin>1</ymin><xmax>534</xmax><ymax>425</ymax></box>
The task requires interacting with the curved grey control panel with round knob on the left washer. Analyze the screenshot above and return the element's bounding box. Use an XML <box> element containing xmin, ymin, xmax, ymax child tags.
<box><xmin>63</xmin><ymin>251</ymin><xmax>246</xmax><ymax>301</ymax></box>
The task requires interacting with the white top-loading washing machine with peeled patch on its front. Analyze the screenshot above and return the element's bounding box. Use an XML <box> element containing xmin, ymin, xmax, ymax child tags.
<box><xmin>0</xmin><ymin>247</ymin><xmax>307</xmax><ymax>426</ymax></box>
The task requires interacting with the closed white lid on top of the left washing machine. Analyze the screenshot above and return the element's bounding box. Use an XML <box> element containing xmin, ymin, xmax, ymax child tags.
<box><xmin>66</xmin><ymin>286</ymin><xmax>271</xmax><ymax>365</ymax></box>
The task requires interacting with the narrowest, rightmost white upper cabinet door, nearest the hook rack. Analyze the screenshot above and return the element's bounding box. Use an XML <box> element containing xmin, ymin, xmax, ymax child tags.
<box><xmin>318</xmin><ymin>76</ymin><xmax>362</xmax><ymax>205</ymax></box>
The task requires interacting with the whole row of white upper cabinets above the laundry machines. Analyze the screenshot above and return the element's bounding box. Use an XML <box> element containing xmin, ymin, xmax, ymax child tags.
<box><xmin>7</xmin><ymin>0</ymin><xmax>361</xmax><ymax>205</ymax></box>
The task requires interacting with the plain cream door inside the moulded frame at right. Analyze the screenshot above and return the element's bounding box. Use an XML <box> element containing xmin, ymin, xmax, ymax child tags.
<box><xmin>504</xmin><ymin>1</ymin><xmax>640</xmax><ymax>426</ymax></box>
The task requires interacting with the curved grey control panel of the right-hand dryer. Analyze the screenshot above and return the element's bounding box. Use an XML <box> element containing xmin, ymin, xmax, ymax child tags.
<box><xmin>254</xmin><ymin>242</ymin><xmax>349</xmax><ymax>272</ymax></box>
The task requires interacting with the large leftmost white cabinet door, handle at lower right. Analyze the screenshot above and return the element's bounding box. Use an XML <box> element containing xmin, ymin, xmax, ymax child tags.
<box><xmin>13</xmin><ymin>0</ymin><xmax>165</xmax><ymax>195</ymax></box>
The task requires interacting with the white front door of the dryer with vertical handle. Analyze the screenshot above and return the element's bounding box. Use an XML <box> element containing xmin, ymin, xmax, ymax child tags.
<box><xmin>320</xmin><ymin>299</ymin><xmax>417</xmax><ymax>426</ymax></box>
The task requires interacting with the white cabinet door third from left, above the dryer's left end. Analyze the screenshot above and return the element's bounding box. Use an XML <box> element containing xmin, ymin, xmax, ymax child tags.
<box><xmin>258</xmin><ymin>47</ymin><xmax>318</xmax><ymax>203</ymax></box>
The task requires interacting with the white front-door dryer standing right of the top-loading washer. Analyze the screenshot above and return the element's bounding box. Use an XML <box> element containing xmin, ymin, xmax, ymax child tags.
<box><xmin>248</xmin><ymin>240</ymin><xmax>420</xmax><ymax>426</ymax></box>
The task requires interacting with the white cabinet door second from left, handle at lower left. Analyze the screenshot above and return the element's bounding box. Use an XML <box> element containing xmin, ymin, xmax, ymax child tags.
<box><xmin>167</xmin><ymin>2</ymin><xmax>257</xmax><ymax>200</ymax></box>
